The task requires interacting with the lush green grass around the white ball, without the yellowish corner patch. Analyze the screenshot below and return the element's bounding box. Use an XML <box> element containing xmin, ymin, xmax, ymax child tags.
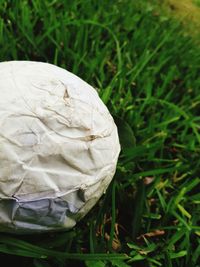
<box><xmin>0</xmin><ymin>0</ymin><xmax>200</xmax><ymax>267</ymax></box>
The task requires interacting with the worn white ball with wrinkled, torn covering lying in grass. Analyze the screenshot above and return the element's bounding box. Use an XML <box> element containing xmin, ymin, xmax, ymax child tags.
<box><xmin>0</xmin><ymin>61</ymin><xmax>120</xmax><ymax>233</ymax></box>
